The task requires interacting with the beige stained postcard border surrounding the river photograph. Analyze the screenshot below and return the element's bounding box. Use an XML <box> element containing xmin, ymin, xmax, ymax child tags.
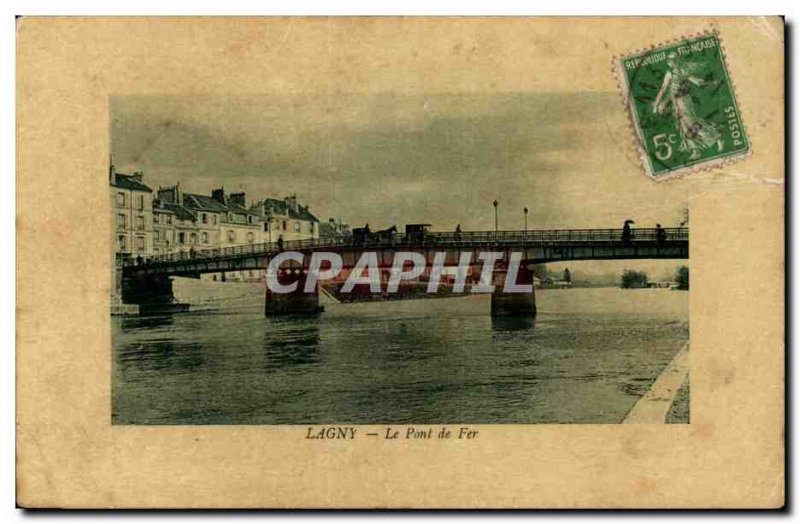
<box><xmin>17</xmin><ymin>18</ymin><xmax>784</xmax><ymax>508</ymax></box>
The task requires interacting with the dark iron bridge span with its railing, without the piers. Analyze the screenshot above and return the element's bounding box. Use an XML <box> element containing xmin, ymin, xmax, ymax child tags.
<box><xmin>123</xmin><ymin>227</ymin><xmax>689</xmax><ymax>275</ymax></box>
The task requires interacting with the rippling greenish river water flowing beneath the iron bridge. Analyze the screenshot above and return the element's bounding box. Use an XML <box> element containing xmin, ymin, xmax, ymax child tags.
<box><xmin>112</xmin><ymin>284</ymin><xmax>689</xmax><ymax>424</ymax></box>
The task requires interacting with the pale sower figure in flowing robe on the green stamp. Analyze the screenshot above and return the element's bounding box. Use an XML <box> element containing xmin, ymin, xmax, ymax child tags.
<box><xmin>652</xmin><ymin>53</ymin><xmax>724</xmax><ymax>160</ymax></box>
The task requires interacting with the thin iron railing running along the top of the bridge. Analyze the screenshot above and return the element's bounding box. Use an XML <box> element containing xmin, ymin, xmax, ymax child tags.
<box><xmin>122</xmin><ymin>227</ymin><xmax>689</xmax><ymax>267</ymax></box>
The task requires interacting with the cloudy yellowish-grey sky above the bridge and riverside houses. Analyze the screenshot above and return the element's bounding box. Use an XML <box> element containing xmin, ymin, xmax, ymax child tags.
<box><xmin>111</xmin><ymin>92</ymin><xmax>688</xmax><ymax>278</ymax></box>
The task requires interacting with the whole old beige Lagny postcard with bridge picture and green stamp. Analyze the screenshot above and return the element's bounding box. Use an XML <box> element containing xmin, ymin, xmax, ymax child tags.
<box><xmin>17</xmin><ymin>17</ymin><xmax>785</xmax><ymax>509</ymax></box>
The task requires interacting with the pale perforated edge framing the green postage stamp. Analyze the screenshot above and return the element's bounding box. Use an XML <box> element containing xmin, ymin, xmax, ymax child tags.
<box><xmin>611</xmin><ymin>26</ymin><xmax>753</xmax><ymax>182</ymax></box>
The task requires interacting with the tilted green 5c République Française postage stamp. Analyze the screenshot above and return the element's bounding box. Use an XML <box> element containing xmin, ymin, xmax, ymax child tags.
<box><xmin>615</xmin><ymin>33</ymin><xmax>750</xmax><ymax>179</ymax></box>
